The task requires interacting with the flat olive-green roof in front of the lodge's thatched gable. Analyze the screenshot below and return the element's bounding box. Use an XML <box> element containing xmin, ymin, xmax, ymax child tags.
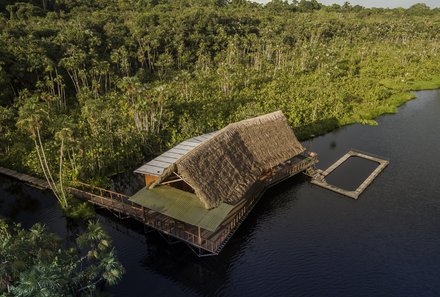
<box><xmin>130</xmin><ymin>185</ymin><xmax>234</xmax><ymax>231</ymax></box>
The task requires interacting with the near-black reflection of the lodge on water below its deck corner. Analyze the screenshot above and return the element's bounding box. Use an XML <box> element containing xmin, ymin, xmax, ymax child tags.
<box><xmin>98</xmin><ymin>210</ymin><xmax>237</xmax><ymax>296</ymax></box>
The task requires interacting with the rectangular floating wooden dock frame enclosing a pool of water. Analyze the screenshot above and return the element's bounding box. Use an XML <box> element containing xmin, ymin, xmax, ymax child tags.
<box><xmin>311</xmin><ymin>150</ymin><xmax>389</xmax><ymax>199</ymax></box>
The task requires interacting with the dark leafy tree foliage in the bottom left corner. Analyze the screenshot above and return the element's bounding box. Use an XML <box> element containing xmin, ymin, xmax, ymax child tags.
<box><xmin>0</xmin><ymin>219</ymin><xmax>124</xmax><ymax>297</ymax></box>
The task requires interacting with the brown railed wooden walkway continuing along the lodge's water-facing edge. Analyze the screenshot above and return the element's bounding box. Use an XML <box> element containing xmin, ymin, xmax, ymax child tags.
<box><xmin>0</xmin><ymin>157</ymin><xmax>318</xmax><ymax>256</ymax></box>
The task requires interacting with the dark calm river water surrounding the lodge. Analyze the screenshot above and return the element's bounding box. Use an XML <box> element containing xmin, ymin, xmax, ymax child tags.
<box><xmin>0</xmin><ymin>91</ymin><xmax>440</xmax><ymax>297</ymax></box>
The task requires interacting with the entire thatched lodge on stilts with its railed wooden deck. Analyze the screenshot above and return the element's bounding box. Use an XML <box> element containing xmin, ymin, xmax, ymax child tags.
<box><xmin>72</xmin><ymin>111</ymin><xmax>317</xmax><ymax>256</ymax></box>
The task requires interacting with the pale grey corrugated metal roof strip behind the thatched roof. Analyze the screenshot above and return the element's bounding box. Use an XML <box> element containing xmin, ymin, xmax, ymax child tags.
<box><xmin>134</xmin><ymin>132</ymin><xmax>217</xmax><ymax>176</ymax></box>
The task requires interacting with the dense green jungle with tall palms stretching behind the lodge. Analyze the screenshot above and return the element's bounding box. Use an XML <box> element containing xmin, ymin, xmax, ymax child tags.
<box><xmin>0</xmin><ymin>0</ymin><xmax>440</xmax><ymax>180</ymax></box>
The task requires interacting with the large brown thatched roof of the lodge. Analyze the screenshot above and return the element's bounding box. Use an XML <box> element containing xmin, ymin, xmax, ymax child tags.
<box><xmin>154</xmin><ymin>111</ymin><xmax>304</xmax><ymax>208</ymax></box>
